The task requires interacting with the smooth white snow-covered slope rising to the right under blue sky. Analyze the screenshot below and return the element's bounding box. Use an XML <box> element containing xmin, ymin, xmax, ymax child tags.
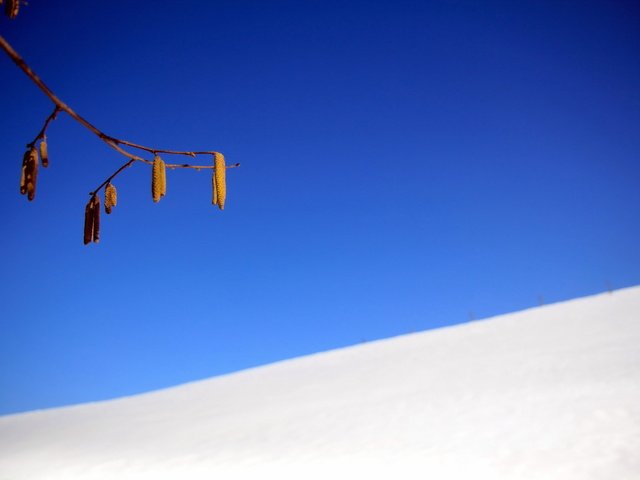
<box><xmin>0</xmin><ymin>287</ymin><xmax>640</xmax><ymax>480</ymax></box>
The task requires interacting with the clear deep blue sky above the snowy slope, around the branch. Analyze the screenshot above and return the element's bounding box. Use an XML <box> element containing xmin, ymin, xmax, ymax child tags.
<box><xmin>0</xmin><ymin>0</ymin><xmax>640</xmax><ymax>413</ymax></box>
